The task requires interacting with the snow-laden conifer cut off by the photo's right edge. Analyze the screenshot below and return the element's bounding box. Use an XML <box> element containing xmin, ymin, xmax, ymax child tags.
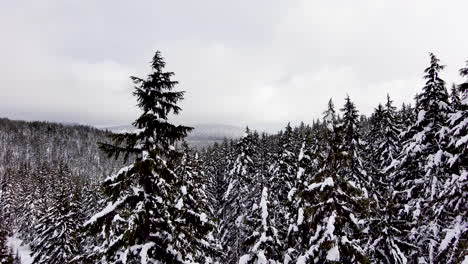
<box><xmin>435</xmin><ymin>58</ymin><xmax>468</xmax><ymax>264</ymax></box>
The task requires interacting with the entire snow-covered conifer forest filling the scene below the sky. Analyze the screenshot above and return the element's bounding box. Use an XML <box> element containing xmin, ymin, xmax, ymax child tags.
<box><xmin>0</xmin><ymin>52</ymin><xmax>468</xmax><ymax>264</ymax></box>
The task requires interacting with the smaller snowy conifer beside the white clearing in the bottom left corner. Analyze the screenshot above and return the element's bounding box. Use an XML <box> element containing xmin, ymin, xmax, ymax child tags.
<box><xmin>31</xmin><ymin>164</ymin><xmax>83</xmax><ymax>264</ymax></box>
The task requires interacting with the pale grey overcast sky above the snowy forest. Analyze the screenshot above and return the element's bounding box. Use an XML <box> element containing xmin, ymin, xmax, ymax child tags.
<box><xmin>0</xmin><ymin>0</ymin><xmax>468</xmax><ymax>131</ymax></box>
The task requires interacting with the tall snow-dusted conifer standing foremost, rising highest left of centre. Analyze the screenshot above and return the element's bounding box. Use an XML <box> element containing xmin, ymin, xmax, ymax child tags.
<box><xmin>85</xmin><ymin>51</ymin><xmax>210</xmax><ymax>264</ymax></box>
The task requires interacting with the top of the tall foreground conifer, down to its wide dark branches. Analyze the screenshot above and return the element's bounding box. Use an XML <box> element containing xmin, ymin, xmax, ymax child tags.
<box><xmin>99</xmin><ymin>51</ymin><xmax>193</xmax><ymax>160</ymax></box>
